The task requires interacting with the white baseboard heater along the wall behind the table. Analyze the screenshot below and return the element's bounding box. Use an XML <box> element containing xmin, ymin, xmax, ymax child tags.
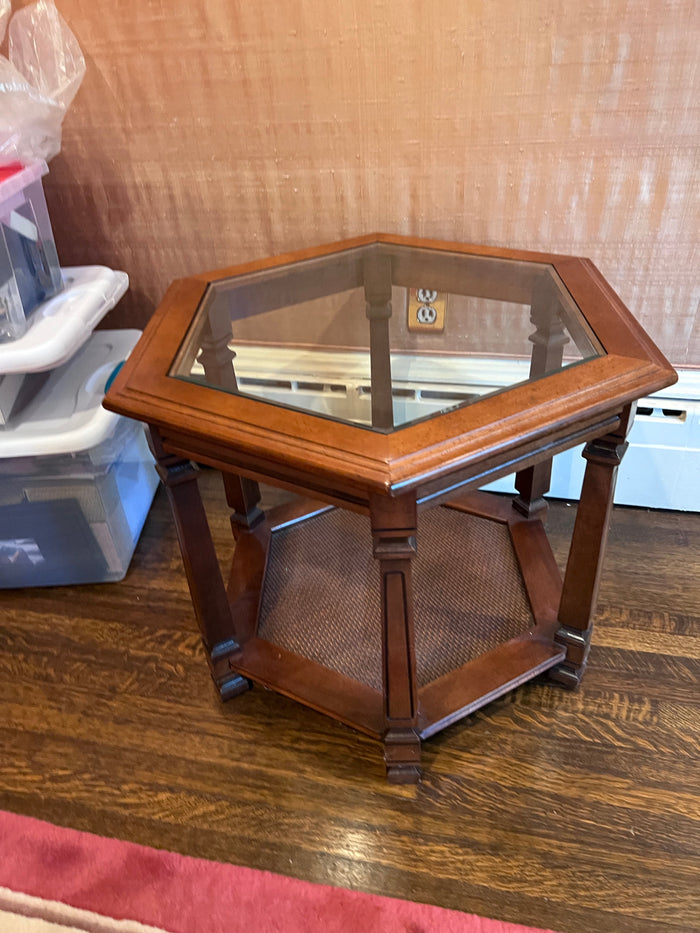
<box><xmin>194</xmin><ymin>343</ymin><xmax>700</xmax><ymax>512</ymax></box>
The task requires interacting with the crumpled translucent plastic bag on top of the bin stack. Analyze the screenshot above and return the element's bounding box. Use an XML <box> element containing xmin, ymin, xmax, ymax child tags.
<box><xmin>0</xmin><ymin>0</ymin><xmax>85</xmax><ymax>165</ymax></box>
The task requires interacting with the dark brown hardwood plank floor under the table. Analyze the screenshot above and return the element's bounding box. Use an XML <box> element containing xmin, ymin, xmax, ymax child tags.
<box><xmin>0</xmin><ymin>471</ymin><xmax>700</xmax><ymax>933</ymax></box>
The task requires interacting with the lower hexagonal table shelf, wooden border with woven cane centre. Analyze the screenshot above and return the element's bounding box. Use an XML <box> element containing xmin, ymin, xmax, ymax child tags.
<box><xmin>217</xmin><ymin>494</ymin><xmax>565</xmax><ymax>739</ymax></box>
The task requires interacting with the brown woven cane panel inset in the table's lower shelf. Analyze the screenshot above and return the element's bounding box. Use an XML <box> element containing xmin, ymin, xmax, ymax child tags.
<box><xmin>258</xmin><ymin>508</ymin><xmax>533</xmax><ymax>690</ymax></box>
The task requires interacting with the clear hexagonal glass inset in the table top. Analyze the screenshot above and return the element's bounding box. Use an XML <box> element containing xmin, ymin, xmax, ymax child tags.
<box><xmin>169</xmin><ymin>243</ymin><xmax>604</xmax><ymax>433</ymax></box>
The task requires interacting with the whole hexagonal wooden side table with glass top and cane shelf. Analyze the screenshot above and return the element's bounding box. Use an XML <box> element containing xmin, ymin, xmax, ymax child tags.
<box><xmin>105</xmin><ymin>235</ymin><xmax>675</xmax><ymax>782</ymax></box>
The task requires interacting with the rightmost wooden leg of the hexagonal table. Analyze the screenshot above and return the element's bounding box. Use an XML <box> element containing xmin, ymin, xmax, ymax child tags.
<box><xmin>549</xmin><ymin>407</ymin><xmax>634</xmax><ymax>688</ymax></box>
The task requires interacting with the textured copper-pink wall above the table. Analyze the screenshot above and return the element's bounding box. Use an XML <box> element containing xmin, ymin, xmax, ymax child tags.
<box><xmin>21</xmin><ymin>0</ymin><xmax>700</xmax><ymax>365</ymax></box>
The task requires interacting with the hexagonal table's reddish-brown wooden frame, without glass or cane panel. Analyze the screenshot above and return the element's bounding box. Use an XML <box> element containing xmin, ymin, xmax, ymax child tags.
<box><xmin>105</xmin><ymin>235</ymin><xmax>676</xmax><ymax>782</ymax></box>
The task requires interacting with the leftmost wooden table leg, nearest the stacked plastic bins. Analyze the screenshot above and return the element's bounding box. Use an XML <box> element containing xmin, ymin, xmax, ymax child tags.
<box><xmin>150</xmin><ymin>428</ymin><xmax>249</xmax><ymax>699</ymax></box>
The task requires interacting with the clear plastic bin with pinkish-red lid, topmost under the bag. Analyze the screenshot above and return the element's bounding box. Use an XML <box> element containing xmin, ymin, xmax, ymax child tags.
<box><xmin>0</xmin><ymin>162</ymin><xmax>63</xmax><ymax>343</ymax></box>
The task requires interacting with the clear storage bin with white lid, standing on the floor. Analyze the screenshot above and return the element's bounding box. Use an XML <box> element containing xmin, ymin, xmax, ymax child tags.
<box><xmin>0</xmin><ymin>330</ymin><xmax>158</xmax><ymax>588</ymax></box>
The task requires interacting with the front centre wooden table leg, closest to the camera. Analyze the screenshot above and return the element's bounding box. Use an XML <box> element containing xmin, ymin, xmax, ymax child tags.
<box><xmin>370</xmin><ymin>496</ymin><xmax>420</xmax><ymax>784</ymax></box>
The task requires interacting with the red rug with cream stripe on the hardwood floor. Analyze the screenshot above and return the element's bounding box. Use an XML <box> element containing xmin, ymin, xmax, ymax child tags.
<box><xmin>0</xmin><ymin>811</ymin><xmax>551</xmax><ymax>933</ymax></box>
